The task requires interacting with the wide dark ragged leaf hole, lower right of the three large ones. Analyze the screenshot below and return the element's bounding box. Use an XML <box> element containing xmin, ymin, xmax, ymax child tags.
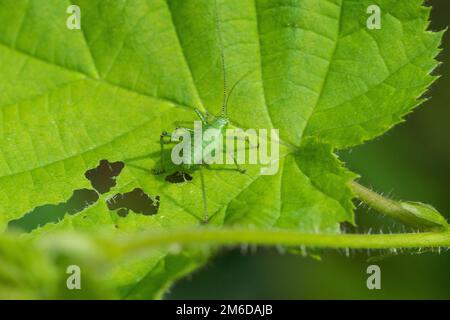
<box><xmin>106</xmin><ymin>188</ymin><xmax>160</xmax><ymax>217</ymax></box>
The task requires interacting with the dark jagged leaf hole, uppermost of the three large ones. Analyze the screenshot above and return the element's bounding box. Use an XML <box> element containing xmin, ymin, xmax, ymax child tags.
<box><xmin>84</xmin><ymin>160</ymin><xmax>125</xmax><ymax>194</ymax></box>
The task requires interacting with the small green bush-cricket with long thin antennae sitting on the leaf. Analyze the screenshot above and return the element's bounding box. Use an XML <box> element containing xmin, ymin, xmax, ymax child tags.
<box><xmin>154</xmin><ymin>4</ymin><xmax>251</xmax><ymax>223</ymax></box>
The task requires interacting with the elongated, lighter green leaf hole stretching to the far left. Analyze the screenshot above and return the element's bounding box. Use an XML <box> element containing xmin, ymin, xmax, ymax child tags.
<box><xmin>8</xmin><ymin>189</ymin><xmax>99</xmax><ymax>232</ymax></box>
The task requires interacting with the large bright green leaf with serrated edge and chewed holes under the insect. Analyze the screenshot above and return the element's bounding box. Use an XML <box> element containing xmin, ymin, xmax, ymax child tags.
<box><xmin>0</xmin><ymin>0</ymin><xmax>442</xmax><ymax>297</ymax></box>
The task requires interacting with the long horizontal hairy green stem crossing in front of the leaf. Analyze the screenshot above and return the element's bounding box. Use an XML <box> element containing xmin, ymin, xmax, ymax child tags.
<box><xmin>121</xmin><ymin>227</ymin><xmax>450</xmax><ymax>251</ymax></box>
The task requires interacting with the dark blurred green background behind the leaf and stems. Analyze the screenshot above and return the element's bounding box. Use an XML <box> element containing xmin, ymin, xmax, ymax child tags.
<box><xmin>167</xmin><ymin>0</ymin><xmax>450</xmax><ymax>299</ymax></box>
